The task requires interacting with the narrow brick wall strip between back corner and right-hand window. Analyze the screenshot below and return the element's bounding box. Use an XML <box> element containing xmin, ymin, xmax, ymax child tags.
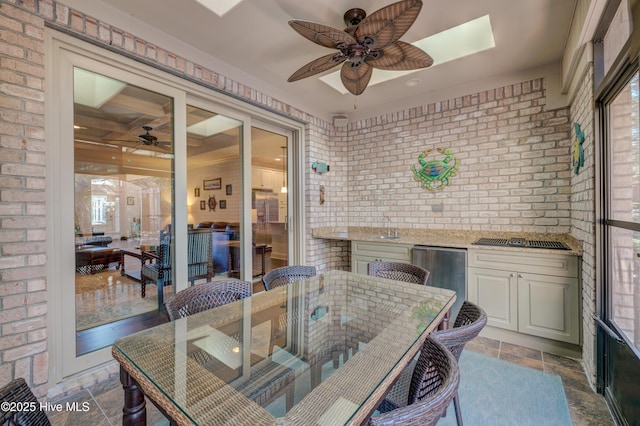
<box><xmin>571</xmin><ymin>66</ymin><xmax>596</xmax><ymax>384</ymax></box>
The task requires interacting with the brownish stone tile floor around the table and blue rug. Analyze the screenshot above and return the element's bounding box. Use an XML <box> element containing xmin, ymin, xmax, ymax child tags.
<box><xmin>50</xmin><ymin>337</ymin><xmax>615</xmax><ymax>426</ymax></box>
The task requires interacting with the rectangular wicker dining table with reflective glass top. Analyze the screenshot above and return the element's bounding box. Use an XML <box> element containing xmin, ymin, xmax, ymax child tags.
<box><xmin>112</xmin><ymin>271</ymin><xmax>456</xmax><ymax>425</ymax></box>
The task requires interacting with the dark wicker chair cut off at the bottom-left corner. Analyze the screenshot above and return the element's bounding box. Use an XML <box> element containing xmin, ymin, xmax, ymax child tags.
<box><xmin>0</xmin><ymin>377</ymin><xmax>51</xmax><ymax>426</ymax></box>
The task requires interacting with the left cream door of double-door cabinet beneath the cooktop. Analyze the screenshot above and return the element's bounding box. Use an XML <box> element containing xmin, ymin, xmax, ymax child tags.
<box><xmin>467</xmin><ymin>268</ymin><xmax>518</xmax><ymax>331</ymax></box>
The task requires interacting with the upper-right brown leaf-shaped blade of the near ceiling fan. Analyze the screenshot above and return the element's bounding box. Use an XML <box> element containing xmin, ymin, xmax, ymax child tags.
<box><xmin>353</xmin><ymin>0</ymin><xmax>422</xmax><ymax>49</ymax></box>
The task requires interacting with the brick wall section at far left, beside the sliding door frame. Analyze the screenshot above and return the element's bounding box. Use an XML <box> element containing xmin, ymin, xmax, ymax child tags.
<box><xmin>0</xmin><ymin>2</ymin><xmax>48</xmax><ymax>394</ymax></box>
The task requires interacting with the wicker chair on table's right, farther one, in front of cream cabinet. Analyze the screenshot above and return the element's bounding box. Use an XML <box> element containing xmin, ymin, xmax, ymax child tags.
<box><xmin>431</xmin><ymin>300</ymin><xmax>487</xmax><ymax>426</ymax></box>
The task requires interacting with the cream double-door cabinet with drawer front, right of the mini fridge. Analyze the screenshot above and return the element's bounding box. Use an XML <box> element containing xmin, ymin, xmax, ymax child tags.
<box><xmin>467</xmin><ymin>249</ymin><xmax>580</xmax><ymax>344</ymax></box>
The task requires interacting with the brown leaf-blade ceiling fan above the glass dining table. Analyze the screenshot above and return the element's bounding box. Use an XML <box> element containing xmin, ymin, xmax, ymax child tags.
<box><xmin>287</xmin><ymin>0</ymin><xmax>433</xmax><ymax>95</ymax></box>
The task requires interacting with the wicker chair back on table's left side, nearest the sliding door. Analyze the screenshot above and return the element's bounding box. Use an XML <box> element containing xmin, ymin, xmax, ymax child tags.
<box><xmin>164</xmin><ymin>280</ymin><xmax>252</xmax><ymax>321</ymax></box>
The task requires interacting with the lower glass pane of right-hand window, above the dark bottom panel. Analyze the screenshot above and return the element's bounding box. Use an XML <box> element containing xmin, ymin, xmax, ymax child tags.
<box><xmin>609</xmin><ymin>228</ymin><xmax>640</xmax><ymax>349</ymax></box>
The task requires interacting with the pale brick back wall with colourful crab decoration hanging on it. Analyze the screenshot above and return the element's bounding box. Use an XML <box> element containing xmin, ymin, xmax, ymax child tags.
<box><xmin>346</xmin><ymin>79</ymin><xmax>571</xmax><ymax>233</ymax></box>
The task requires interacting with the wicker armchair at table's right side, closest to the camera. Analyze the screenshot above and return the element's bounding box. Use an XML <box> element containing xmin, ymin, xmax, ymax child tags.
<box><xmin>369</xmin><ymin>336</ymin><xmax>460</xmax><ymax>426</ymax></box>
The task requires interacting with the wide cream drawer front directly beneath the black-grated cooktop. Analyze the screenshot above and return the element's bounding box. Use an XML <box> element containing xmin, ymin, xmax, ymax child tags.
<box><xmin>468</xmin><ymin>249</ymin><xmax>578</xmax><ymax>277</ymax></box>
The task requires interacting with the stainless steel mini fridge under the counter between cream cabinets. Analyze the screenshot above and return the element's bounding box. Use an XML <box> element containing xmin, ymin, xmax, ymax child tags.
<box><xmin>412</xmin><ymin>246</ymin><xmax>467</xmax><ymax>326</ymax></box>
